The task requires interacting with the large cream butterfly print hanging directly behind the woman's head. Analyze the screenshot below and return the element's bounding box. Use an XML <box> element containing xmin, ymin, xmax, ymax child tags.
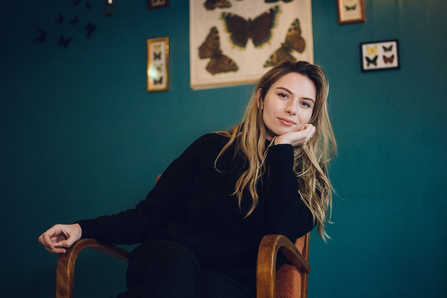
<box><xmin>189</xmin><ymin>0</ymin><xmax>313</xmax><ymax>89</ymax></box>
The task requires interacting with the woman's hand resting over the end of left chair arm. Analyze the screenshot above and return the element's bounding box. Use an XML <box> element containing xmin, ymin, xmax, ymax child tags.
<box><xmin>39</xmin><ymin>224</ymin><xmax>82</xmax><ymax>253</ymax></box>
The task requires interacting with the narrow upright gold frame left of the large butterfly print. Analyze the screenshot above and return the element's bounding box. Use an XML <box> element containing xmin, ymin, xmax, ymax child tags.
<box><xmin>146</xmin><ymin>37</ymin><xmax>169</xmax><ymax>92</ymax></box>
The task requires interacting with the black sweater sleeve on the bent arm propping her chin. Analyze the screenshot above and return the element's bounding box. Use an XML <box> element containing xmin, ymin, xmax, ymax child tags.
<box><xmin>263</xmin><ymin>144</ymin><xmax>315</xmax><ymax>241</ymax></box>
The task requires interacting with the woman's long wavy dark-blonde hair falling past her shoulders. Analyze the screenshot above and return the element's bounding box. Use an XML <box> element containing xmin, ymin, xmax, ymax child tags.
<box><xmin>215</xmin><ymin>61</ymin><xmax>337</xmax><ymax>241</ymax></box>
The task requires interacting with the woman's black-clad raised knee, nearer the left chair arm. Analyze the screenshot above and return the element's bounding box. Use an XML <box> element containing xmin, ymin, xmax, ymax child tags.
<box><xmin>118</xmin><ymin>240</ymin><xmax>202</xmax><ymax>298</ymax></box>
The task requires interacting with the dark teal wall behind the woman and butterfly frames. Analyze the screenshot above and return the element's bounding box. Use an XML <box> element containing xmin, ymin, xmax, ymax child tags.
<box><xmin>0</xmin><ymin>0</ymin><xmax>447</xmax><ymax>298</ymax></box>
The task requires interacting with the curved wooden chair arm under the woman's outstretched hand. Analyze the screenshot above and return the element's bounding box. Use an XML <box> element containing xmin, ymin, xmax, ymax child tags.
<box><xmin>56</xmin><ymin>239</ymin><xmax>130</xmax><ymax>298</ymax></box>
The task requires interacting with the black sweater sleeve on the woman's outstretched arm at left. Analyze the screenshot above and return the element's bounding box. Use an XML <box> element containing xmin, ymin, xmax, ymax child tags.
<box><xmin>78</xmin><ymin>136</ymin><xmax>207</xmax><ymax>244</ymax></box>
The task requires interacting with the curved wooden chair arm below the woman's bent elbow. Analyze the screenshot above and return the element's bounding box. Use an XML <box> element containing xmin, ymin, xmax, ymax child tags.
<box><xmin>256</xmin><ymin>235</ymin><xmax>310</xmax><ymax>298</ymax></box>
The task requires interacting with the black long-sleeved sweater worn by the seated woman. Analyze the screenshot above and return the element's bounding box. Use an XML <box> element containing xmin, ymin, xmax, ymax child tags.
<box><xmin>78</xmin><ymin>134</ymin><xmax>314</xmax><ymax>284</ymax></box>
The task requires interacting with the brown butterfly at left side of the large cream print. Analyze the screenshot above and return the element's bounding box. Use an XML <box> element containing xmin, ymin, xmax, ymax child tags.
<box><xmin>199</xmin><ymin>27</ymin><xmax>239</xmax><ymax>75</ymax></box>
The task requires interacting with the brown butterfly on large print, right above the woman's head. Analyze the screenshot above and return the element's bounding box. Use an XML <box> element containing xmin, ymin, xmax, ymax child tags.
<box><xmin>264</xmin><ymin>19</ymin><xmax>306</xmax><ymax>67</ymax></box>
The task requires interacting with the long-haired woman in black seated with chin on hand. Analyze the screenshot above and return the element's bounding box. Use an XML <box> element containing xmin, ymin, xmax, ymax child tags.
<box><xmin>39</xmin><ymin>62</ymin><xmax>336</xmax><ymax>298</ymax></box>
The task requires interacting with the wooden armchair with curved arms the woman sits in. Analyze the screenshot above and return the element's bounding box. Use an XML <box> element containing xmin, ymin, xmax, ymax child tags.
<box><xmin>56</xmin><ymin>234</ymin><xmax>310</xmax><ymax>298</ymax></box>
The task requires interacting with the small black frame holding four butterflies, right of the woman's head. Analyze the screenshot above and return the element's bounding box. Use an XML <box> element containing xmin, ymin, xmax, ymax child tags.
<box><xmin>360</xmin><ymin>39</ymin><xmax>400</xmax><ymax>72</ymax></box>
